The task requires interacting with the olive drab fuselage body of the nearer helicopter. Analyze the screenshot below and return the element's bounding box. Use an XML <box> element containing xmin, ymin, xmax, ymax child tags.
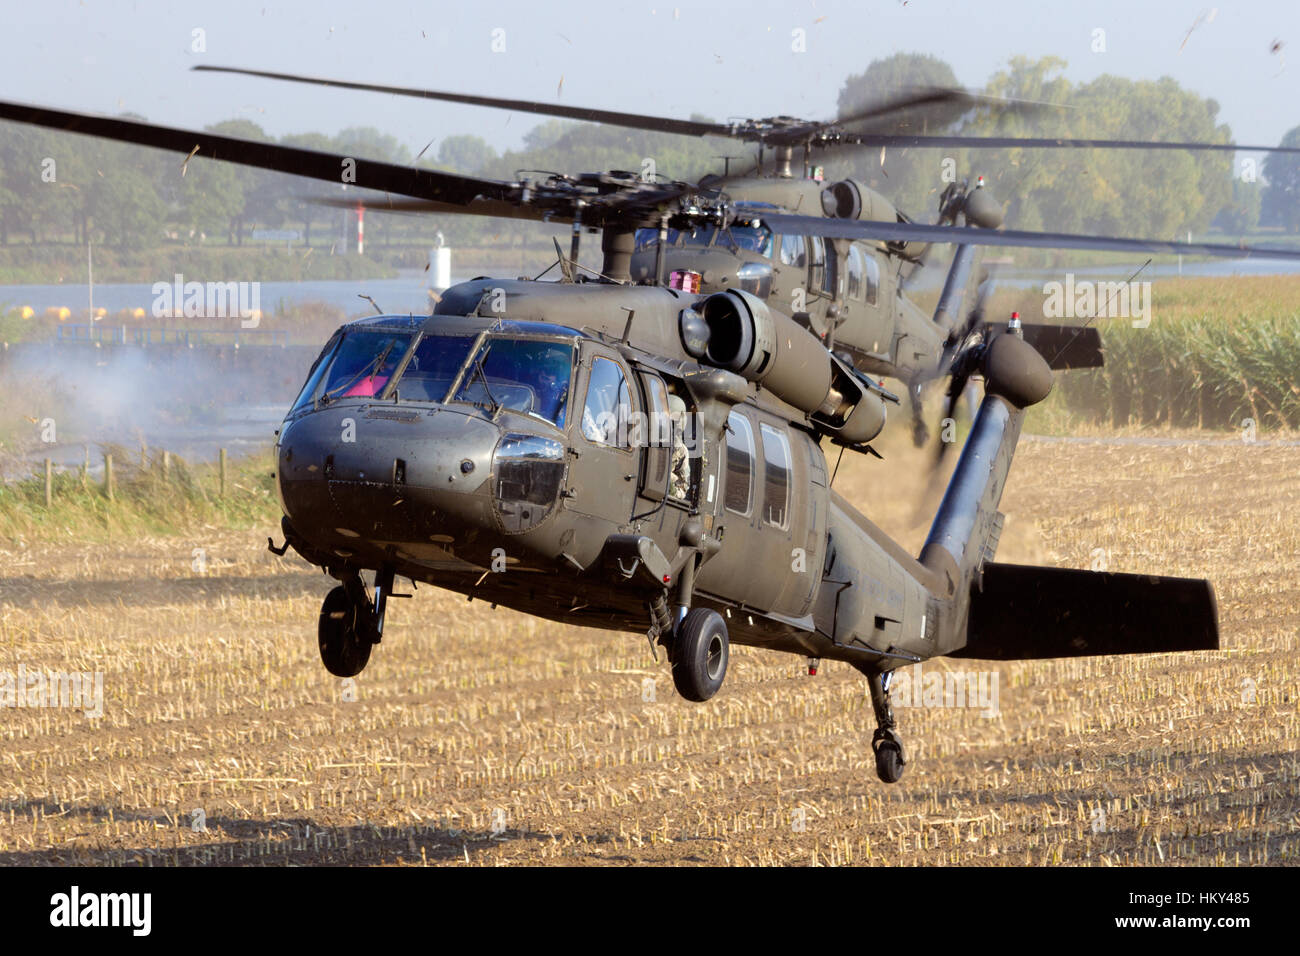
<box><xmin>277</xmin><ymin>280</ymin><xmax>939</xmax><ymax>659</ymax></box>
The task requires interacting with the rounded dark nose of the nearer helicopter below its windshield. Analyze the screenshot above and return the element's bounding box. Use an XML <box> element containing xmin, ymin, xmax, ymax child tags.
<box><xmin>277</xmin><ymin>406</ymin><xmax>501</xmax><ymax>555</ymax></box>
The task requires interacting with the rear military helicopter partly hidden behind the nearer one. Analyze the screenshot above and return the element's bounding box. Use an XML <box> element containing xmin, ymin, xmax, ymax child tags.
<box><xmin>194</xmin><ymin>65</ymin><xmax>1300</xmax><ymax>450</ymax></box>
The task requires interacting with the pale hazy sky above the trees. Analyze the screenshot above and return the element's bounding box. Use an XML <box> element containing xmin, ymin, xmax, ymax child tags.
<box><xmin>0</xmin><ymin>0</ymin><xmax>1300</xmax><ymax>159</ymax></box>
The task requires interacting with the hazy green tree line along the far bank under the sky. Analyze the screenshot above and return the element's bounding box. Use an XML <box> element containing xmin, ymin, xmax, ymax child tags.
<box><xmin>0</xmin><ymin>53</ymin><xmax>1300</xmax><ymax>251</ymax></box>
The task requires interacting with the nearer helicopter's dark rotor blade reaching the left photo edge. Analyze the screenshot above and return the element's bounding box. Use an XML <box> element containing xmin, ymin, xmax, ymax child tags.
<box><xmin>0</xmin><ymin>100</ymin><xmax>542</xmax><ymax>219</ymax></box>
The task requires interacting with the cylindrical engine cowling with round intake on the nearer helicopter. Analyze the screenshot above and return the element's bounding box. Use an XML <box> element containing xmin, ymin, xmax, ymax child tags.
<box><xmin>681</xmin><ymin>289</ymin><xmax>885</xmax><ymax>444</ymax></box>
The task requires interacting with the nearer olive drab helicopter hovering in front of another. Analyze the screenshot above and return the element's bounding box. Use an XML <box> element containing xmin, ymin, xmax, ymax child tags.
<box><xmin>0</xmin><ymin>80</ymin><xmax>1300</xmax><ymax>782</ymax></box>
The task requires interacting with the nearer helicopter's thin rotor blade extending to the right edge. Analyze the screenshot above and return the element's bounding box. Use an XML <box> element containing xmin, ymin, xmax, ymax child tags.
<box><xmin>754</xmin><ymin>204</ymin><xmax>1300</xmax><ymax>261</ymax></box>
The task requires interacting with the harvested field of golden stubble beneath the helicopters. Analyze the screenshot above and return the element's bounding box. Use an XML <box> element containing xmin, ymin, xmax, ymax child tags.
<box><xmin>0</xmin><ymin>438</ymin><xmax>1300</xmax><ymax>865</ymax></box>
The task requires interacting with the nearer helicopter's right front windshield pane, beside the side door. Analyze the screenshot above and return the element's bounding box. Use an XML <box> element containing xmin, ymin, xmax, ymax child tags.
<box><xmin>449</xmin><ymin>336</ymin><xmax>573</xmax><ymax>428</ymax></box>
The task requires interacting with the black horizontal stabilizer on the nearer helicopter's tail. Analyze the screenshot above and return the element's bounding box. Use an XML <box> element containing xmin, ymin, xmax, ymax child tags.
<box><xmin>952</xmin><ymin>563</ymin><xmax>1219</xmax><ymax>661</ymax></box>
